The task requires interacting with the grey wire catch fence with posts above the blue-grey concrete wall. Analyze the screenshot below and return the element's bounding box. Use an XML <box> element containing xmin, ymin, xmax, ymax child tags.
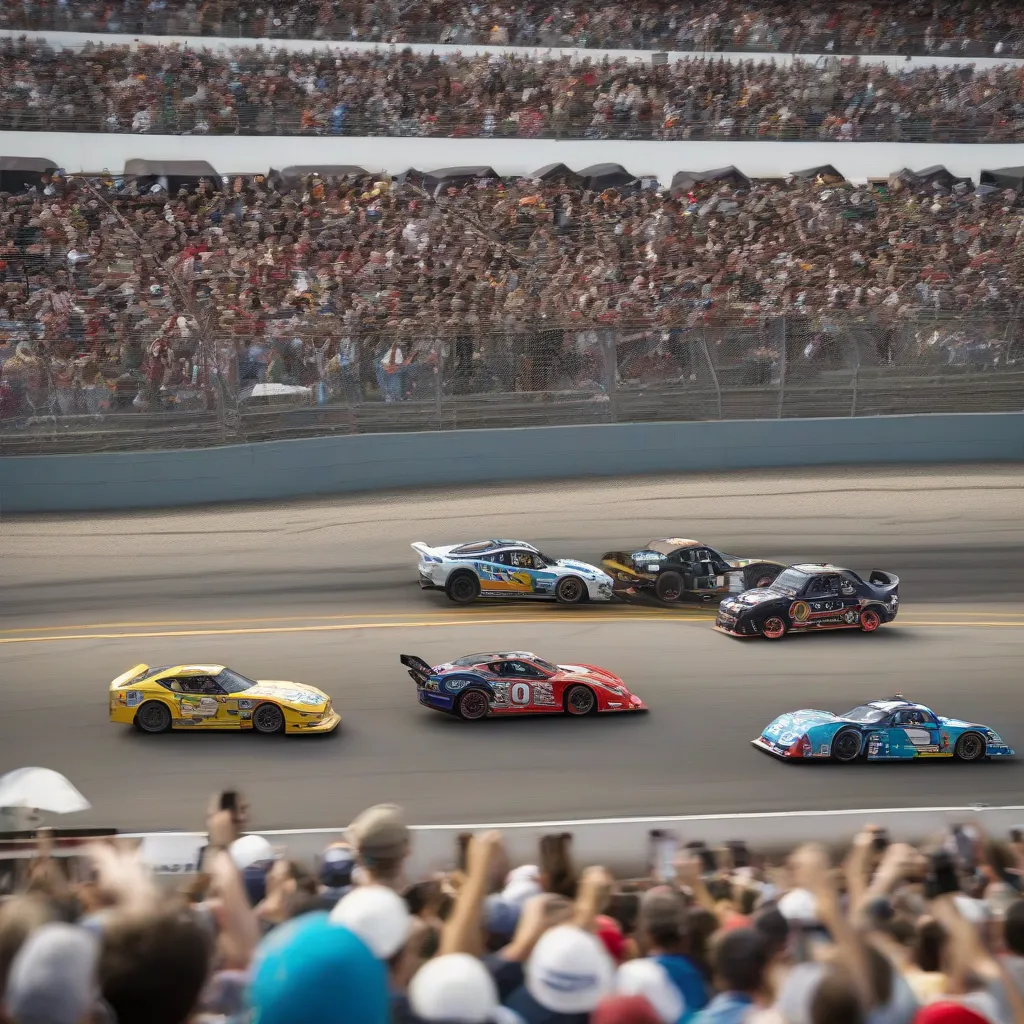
<box><xmin>0</xmin><ymin>313</ymin><xmax>1024</xmax><ymax>455</ymax></box>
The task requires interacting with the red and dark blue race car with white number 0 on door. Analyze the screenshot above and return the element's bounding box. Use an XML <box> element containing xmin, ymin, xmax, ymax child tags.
<box><xmin>400</xmin><ymin>650</ymin><xmax>647</xmax><ymax>722</ymax></box>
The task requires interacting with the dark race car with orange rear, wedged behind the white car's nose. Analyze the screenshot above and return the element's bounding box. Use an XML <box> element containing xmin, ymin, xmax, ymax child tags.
<box><xmin>601</xmin><ymin>537</ymin><xmax>785</xmax><ymax>603</ymax></box>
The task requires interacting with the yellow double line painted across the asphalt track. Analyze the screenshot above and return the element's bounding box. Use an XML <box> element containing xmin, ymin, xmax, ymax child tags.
<box><xmin>0</xmin><ymin>613</ymin><xmax>1024</xmax><ymax>644</ymax></box>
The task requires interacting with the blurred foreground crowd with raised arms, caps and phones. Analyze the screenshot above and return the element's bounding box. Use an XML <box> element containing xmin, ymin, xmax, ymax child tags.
<box><xmin>0</xmin><ymin>800</ymin><xmax>1024</xmax><ymax>1024</ymax></box>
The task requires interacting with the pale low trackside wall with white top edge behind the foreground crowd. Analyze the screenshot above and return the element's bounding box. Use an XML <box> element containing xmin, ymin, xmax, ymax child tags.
<box><xmin>0</xmin><ymin>805</ymin><xmax>1024</xmax><ymax>877</ymax></box>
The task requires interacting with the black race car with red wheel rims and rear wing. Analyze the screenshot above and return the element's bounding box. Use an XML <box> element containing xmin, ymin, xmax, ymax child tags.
<box><xmin>715</xmin><ymin>564</ymin><xmax>899</xmax><ymax>640</ymax></box>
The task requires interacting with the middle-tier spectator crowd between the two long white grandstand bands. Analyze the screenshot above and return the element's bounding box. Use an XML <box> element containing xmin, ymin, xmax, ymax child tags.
<box><xmin>0</xmin><ymin>37</ymin><xmax>1024</xmax><ymax>142</ymax></box>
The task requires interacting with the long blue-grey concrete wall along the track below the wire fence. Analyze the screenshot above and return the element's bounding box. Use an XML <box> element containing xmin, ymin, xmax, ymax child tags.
<box><xmin>0</xmin><ymin>413</ymin><xmax>1024</xmax><ymax>514</ymax></box>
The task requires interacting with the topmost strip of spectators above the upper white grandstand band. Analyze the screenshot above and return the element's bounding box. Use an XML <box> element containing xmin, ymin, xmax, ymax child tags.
<box><xmin>0</xmin><ymin>0</ymin><xmax>1024</xmax><ymax>55</ymax></box>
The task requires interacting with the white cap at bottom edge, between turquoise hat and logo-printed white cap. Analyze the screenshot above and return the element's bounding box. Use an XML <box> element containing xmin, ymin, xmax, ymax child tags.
<box><xmin>409</xmin><ymin>953</ymin><xmax>514</xmax><ymax>1024</ymax></box>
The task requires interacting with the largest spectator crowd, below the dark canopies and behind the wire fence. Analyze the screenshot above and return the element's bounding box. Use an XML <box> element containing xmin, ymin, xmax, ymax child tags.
<box><xmin>0</xmin><ymin>166</ymin><xmax>1024</xmax><ymax>417</ymax></box>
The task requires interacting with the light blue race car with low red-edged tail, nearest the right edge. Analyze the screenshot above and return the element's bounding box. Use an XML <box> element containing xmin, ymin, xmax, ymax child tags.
<box><xmin>752</xmin><ymin>693</ymin><xmax>1014</xmax><ymax>762</ymax></box>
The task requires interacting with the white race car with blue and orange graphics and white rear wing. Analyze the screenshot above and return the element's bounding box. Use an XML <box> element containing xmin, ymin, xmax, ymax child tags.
<box><xmin>413</xmin><ymin>541</ymin><xmax>612</xmax><ymax>604</ymax></box>
